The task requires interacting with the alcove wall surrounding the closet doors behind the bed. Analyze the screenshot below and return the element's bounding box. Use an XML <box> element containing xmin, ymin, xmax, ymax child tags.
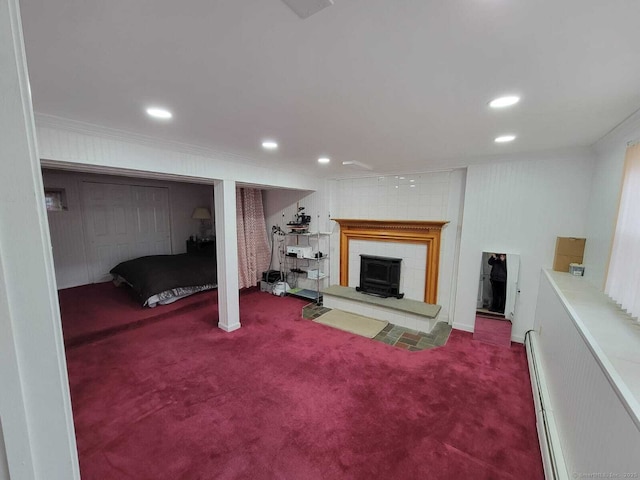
<box><xmin>43</xmin><ymin>169</ymin><xmax>214</xmax><ymax>289</ymax></box>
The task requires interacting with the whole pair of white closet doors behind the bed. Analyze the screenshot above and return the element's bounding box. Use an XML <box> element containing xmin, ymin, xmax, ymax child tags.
<box><xmin>82</xmin><ymin>182</ymin><xmax>171</xmax><ymax>283</ymax></box>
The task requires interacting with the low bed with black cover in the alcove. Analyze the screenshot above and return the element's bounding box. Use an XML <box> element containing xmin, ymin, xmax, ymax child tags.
<box><xmin>110</xmin><ymin>253</ymin><xmax>217</xmax><ymax>307</ymax></box>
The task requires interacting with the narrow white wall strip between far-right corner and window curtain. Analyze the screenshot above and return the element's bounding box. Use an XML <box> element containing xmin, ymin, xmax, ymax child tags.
<box><xmin>584</xmin><ymin>112</ymin><xmax>640</xmax><ymax>290</ymax></box>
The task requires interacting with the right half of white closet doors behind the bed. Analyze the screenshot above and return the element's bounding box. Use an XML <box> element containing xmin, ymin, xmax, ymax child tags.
<box><xmin>132</xmin><ymin>186</ymin><xmax>171</xmax><ymax>257</ymax></box>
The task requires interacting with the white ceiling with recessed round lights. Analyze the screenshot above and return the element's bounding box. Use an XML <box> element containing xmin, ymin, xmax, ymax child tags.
<box><xmin>20</xmin><ymin>0</ymin><xmax>640</xmax><ymax>176</ymax></box>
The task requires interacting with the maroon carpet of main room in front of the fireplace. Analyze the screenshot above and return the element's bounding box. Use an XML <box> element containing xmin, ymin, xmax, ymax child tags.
<box><xmin>63</xmin><ymin>286</ymin><xmax>544</xmax><ymax>480</ymax></box>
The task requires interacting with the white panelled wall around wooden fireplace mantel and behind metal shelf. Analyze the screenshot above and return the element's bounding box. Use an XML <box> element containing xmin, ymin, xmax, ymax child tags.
<box><xmin>264</xmin><ymin>170</ymin><xmax>465</xmax><ymax>314</ymax></box>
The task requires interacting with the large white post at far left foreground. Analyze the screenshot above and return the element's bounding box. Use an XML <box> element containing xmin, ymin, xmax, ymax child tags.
<box><xmin>0</xmin><ymin>0</ymin><xmax>80</xmax><ymax>480</ymax></box>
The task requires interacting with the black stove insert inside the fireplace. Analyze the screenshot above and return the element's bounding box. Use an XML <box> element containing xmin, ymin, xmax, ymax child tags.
<box><xmin>356</xmin><ymin>255</ymin><xmax>404</xmax><ymax>298</ymax></box>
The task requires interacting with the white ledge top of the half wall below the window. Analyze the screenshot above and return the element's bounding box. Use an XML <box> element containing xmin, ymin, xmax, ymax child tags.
<box><xmin>545</xmin><ymin>270</ymin><xmax>640</xmax><ymax>429</ymax></box>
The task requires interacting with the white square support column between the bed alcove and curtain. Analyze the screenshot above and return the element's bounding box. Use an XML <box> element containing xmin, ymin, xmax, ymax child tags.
<box><xmin>213</xmin><ymin>180</ymin><xmax>240</xmax><ymax>332</ymax></box>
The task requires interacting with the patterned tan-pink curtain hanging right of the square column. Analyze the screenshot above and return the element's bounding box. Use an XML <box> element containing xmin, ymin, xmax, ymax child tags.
<box><xmin>236</xmin><ymin>188</ymin><xmax>271</xmax><ymax>288</ymax></box>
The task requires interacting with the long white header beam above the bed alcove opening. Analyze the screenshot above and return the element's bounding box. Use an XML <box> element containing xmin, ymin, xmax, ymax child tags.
<box><xmin>36</xmin><ymin>115</ymin><xmax>323</xmax><ymax>190</ymax></box>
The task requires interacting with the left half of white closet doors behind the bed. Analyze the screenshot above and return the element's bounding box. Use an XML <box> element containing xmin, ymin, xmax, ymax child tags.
<box><xmin>82</xmin><ymin>182</ymin><xmax>135</xmax><ymax>283</ymax></box>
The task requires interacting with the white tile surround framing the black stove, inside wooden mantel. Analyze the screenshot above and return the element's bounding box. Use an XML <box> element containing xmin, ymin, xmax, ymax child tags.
<box><xmin>348</xmin><ymin>240</ymin><xmax>427</xmax><ymax>301</ymax></box>
